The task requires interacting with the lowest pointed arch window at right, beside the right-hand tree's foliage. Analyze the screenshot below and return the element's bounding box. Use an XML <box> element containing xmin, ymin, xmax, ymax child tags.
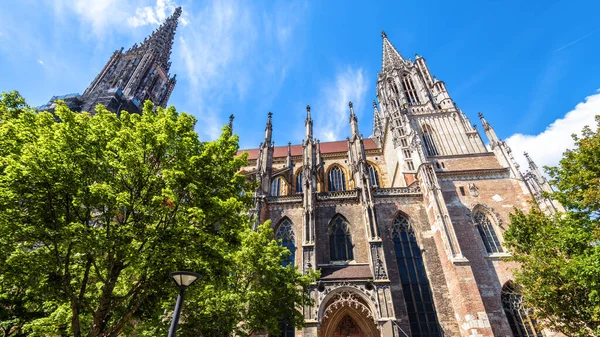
<box><xmin>501</xmin><ymin>282</ymin><xmax>543</xmax><ymax>337</ymax></box>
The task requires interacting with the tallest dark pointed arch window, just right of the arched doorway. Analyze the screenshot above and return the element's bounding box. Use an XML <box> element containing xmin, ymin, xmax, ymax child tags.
<box><xmin>392</xmin><ymin>215</ymin><xmax>441</xmax><ymax>337</ymax></box>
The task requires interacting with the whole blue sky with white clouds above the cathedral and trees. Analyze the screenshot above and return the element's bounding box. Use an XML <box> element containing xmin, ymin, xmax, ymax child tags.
<box><xmin>0</xmin><ymin>0</ymin><xmax>600</xmax><ymax>165</ymax></box>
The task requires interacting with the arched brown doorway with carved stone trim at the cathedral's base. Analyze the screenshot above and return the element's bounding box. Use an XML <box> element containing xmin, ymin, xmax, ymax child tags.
<box><xmin>319</xmin><ymin>290</ymin><xmax>380</xmax><ymax>337</ymax></box>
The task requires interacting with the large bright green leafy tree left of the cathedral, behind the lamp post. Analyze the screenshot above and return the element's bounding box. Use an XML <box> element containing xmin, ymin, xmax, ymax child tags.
<box><xmin>0</xmin><ymin>92</ymin><xmax>314</xmax><ymax>337</ymax></box>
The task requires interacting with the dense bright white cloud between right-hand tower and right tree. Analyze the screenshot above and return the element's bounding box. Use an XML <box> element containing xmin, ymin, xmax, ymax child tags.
<box><xmin>506</xmin><ymin>90</ymin><xmax>600</xmax><ymax>170</ymax></box>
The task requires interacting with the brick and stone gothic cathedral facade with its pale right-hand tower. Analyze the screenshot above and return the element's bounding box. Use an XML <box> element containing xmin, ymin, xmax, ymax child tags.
<box><xmin>240</xmin><ymin>33</ymin><xmax>561</xmax><ymax>337</ymax></box>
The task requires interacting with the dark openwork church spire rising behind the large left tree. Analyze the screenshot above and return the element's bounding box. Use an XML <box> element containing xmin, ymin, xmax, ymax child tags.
<box><xmin>39</xmin><ymin>7</ymin><xmax>181</xmax><ymax>113</ymax></box>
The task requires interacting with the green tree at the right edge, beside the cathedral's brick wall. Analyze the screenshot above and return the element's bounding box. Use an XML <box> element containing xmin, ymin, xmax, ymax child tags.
<box><xmin>505</xmin><ymin>116</ymin><xmax>600</xmax><ymax>337</ymax></box>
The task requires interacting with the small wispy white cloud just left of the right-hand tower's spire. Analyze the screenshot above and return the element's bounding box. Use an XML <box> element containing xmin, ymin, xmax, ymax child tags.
<box><xmin>312</xmin><ymin>67</ymin><xmax>368</xmax><ymax>141</ymax></box>
